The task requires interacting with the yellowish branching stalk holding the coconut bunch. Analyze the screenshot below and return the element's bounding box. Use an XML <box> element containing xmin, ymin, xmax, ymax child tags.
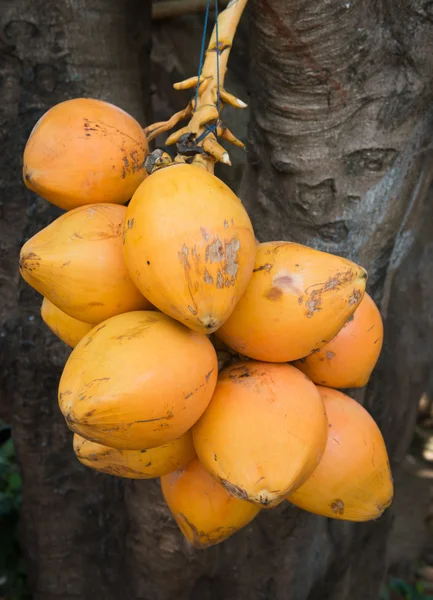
<box><xmin>145</xmin><ymin>0</ymin><xmax>248</xmax><ymax>172</ymax></box>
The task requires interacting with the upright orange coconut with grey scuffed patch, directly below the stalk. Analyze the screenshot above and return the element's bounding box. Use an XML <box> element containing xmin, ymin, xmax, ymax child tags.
<box><xmin>124</xmin><ymin>164</ymin><xmax>257</xmax><ymax>333</ymax></box>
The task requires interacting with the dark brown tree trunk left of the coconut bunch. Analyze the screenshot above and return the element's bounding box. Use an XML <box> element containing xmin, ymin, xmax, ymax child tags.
<box><xmin>0</xmin><ymin>0</ymin><xmax>151</xmax><ymax>600</ymax></box>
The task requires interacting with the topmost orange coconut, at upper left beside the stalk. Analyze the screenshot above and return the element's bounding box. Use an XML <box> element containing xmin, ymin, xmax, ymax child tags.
<box><xmin>23</xmin><ymin>98</ymin><xmax>148</xmax><ymax>210</ymax></box>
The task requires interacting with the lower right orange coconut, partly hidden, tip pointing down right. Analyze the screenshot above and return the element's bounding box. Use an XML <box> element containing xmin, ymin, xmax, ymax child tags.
<box><xmin>288</xmin><ymin>387</ymin><xmax>393</xmax><ymax>521</ymax></box>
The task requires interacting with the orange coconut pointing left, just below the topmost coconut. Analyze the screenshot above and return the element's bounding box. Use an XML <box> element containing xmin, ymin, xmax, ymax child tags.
<box><xmin>20</xmin><ymin>204</ymin><xmax>150</xmax><ymax>324</ymax></box>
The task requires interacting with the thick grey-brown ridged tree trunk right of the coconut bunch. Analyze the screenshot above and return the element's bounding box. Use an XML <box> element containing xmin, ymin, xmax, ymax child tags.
<box><xmin>238</xmin><ymin>0</ymin><xmax>433</xmax><ymax>600</ymax></box>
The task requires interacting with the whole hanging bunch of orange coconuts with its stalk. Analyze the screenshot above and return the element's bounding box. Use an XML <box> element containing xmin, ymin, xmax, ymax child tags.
<box><xmin>20</xmin><ymin>0</ymin><xmax>393</xmax><ymax>548</ymax></box>
